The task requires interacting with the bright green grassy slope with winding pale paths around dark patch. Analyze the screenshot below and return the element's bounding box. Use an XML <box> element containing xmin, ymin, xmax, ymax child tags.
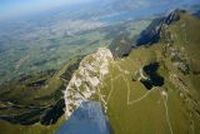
<box><xmin>101</xmin><ymin>14</ymin><xmax>200</xmax><ymax>134</ymax></box>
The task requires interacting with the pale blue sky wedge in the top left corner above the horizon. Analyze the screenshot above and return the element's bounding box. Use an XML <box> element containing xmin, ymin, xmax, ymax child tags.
<box><xmin>0</xmin><ymin>0</ymin><xmax>92</xmax><ymax>19</ymax></box>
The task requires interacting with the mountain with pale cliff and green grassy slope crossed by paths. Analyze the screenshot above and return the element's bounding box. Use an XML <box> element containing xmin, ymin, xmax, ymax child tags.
<box><xmin>61</xmin><ymin>10</ymin><xmax>200</xmax><ymax>134</ymax></box>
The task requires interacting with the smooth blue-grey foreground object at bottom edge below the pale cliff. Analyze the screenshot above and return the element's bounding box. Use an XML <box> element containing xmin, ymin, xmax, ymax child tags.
<box><xmin>57</xmin><ymin>102</ymin><xmax>110</xmax><ymax>134</ymax></box>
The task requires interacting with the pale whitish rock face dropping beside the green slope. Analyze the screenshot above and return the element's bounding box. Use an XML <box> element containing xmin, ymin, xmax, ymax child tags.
<box><xmin>64</xmin><ymin>48</ymin><xmax>113</xmax><ymax>118</ymax></box>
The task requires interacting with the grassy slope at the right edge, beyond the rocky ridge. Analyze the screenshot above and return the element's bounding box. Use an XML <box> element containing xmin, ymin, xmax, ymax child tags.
<box><xmin>170</xmin><ymin>12</ymin><xmax>200</xmax><ymax>94</ymax></box>
